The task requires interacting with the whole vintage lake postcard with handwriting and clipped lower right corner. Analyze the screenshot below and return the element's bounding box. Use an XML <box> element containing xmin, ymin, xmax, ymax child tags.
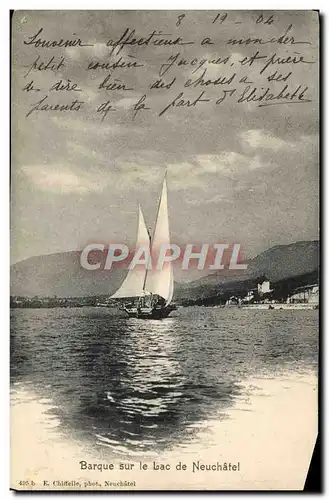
<box><xmin>10</xmin><ymin>10</ymin><xmax>319</xmax><ymax>491</ymax></box>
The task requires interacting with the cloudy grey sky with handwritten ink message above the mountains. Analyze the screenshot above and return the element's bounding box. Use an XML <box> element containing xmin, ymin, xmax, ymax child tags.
<box><xmin>11</xmin><ymin>11</ymin><xmax>319</xmax><ymax>263</ymax></box>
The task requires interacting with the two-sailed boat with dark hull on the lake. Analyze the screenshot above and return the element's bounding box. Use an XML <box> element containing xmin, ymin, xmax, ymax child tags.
<box><xmin>110</xmin><ymin>176</ymin><xmax>176</xmax><ymax>319</ymax></box>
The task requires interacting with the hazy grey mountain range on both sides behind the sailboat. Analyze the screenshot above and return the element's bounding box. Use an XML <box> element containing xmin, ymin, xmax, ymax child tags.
<box><xmin>11</xmin><ymin>241</ymin><xmax>319</xmax><ymax>300</ymax></box>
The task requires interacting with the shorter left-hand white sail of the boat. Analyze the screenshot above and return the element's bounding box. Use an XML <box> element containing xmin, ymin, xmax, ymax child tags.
<box><xmin>111</xmin><ymin>207</ymin><xmax>150</xmax><ymax>299</ymax></box>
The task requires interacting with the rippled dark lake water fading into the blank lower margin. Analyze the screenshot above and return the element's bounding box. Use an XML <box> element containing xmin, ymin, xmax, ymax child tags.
<box><xmin>11</xmin><ymin>307</ymin><xmax>318</xmax><ymax>464</ymax></box>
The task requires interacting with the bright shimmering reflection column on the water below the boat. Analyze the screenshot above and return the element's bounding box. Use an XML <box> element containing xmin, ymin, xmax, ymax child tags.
<box><xmin>88</xmin><ymin>318</ymin><xmax>205</xmax><ymax>453</ymax></box>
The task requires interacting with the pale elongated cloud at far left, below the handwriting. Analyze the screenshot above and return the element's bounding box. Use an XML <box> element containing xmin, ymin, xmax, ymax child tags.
<box><xmin>22</xmin><ymin>165</ymin><xmax>106</xmax><ymax>194</ymax></box>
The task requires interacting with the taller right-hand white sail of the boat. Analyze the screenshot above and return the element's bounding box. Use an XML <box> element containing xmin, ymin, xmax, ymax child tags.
<box><xmin>145</xmin><ymin>179</ymin><xmax>174</xmax><ymax>305</ymax></box>
